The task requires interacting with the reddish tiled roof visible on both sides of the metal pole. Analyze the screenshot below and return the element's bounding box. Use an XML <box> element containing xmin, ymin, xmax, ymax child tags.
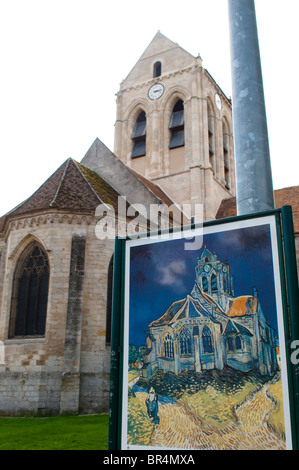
<box><xmin>216</xmin><ymin>186</ymin><xmax>299</xmax><ymax>233</ymax></box>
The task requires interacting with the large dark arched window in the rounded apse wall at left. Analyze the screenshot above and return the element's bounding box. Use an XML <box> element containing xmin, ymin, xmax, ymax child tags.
<box><xmin>10</xmin><ymin>243</ymin><xmax>50</xmax><ymax>338</ymax></box>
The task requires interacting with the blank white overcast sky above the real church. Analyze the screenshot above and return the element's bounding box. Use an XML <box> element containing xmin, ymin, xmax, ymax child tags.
<box><xmin>0</xmin><ymin>0</ymin><xmax>299</xmax><ymax>215</ymax></box>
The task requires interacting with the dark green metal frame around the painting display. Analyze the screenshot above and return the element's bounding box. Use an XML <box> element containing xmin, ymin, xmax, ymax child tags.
<box><xmin>109</xmin><ymin>206</ymin><xmax>299</xmax><ymax>450</ymax></box>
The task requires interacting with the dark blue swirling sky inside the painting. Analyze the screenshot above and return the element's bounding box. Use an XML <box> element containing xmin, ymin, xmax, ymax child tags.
<box><xmin>129</xmin><ymin>225</ymin><xmax>277</xmax><ymax>347</ymax></box>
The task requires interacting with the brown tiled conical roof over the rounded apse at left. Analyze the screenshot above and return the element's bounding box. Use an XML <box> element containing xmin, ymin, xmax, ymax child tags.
<box><xmin>0</xmin><ymin>158</ymin><xmax>119</xmax><ymax>232</ymax></box>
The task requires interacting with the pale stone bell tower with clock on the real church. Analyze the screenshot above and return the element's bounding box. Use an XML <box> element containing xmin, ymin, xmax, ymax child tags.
<box><xmin>114</xmin><ymin>32</ymin><xmax>235</xmax><ymax>220</ymax></box>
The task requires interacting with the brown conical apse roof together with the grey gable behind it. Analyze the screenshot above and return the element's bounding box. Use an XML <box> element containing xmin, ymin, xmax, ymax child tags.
<box><xmin>0</xmin><ymin>134</ymin><xmax>189</xmax><ymax>233</ymax></box>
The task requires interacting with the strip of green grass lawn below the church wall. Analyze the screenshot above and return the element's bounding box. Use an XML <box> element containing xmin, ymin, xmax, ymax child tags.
<box><xmin>0</xmin><ymin>414</ymin><xmax>109</xmax><ymax>450</ymax></box>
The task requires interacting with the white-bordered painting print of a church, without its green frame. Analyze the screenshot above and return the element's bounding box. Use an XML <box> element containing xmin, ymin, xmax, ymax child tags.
<box><xmin>123</xmin><ymin>218</ymin><xmax>289</xmax><ymax>450</ymax></box>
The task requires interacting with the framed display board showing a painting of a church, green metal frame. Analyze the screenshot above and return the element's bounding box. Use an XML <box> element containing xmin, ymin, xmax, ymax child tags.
<box><xmin>109</xmin><ymin>208</ymin><xmax>299</xmax><ymax>451</ymax></box>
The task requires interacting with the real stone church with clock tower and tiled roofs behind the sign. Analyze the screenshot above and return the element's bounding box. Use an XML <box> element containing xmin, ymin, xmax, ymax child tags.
<box><xmin>0</xmin><ymin>32</ymin><xmax>299</xmax><ymax>415</ymax></box>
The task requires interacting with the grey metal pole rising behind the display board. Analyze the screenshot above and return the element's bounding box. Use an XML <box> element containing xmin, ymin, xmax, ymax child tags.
<box><xmin>228</xmin><ymin>0</ymin><xmax>275</xmax><ymax>215</ymax></box>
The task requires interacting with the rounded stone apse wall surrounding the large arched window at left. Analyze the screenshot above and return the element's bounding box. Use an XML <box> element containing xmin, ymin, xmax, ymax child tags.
<box><xmin>0</xmin><ymin>214</ymin><xmax>114</xmax><ymax>415</ymax></box>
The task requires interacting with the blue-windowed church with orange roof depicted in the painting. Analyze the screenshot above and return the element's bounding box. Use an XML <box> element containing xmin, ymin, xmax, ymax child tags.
<box><xmin>144</xmin><ymin>247</ymin><xmax>278</xmax><ymax>378</ymax></box>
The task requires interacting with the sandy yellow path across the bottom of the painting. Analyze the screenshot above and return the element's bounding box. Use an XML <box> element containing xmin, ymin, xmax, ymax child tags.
<box><xmin>136</xmin><ymin>376</ymin><xmax>286</xmax><ymax>450</ymax></box>
